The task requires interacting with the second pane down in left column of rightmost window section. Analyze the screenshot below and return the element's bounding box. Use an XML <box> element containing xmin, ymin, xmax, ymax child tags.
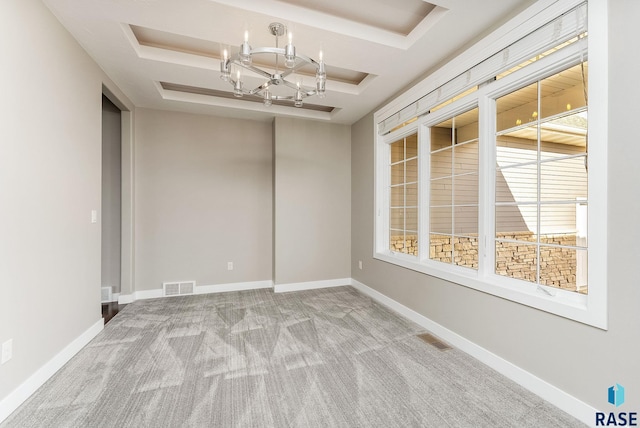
<box><xmin>496</xmin><ymin>131</ymin><xmax>538</xmax><ymax>168</ymax></box>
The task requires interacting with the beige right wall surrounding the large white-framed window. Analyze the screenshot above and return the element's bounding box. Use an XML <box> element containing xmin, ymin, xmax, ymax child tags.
<box><xmin>351</xmin><ymin>0</ymin><xmax>640</xmax><ymax>411</ymax></box>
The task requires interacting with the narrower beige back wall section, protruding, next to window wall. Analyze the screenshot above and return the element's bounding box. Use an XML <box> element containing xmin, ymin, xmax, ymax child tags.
<box><xmin>274</xmin><ymin>118</ymin><xmax>351</xmax><ymax>284</ymax></box>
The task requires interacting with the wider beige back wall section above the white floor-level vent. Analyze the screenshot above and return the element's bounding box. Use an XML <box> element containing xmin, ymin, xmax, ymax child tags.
<box><xmin>135</xmin><ymin>109</ymin><xmax>272</xmax><ymax>291</ymax></box>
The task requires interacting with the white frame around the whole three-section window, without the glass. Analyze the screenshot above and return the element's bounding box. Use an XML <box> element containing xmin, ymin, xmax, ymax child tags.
<box><xmin>373</xmin><ymin>0</ymin><xmax>608</xmax><ymax>329</ymax></box>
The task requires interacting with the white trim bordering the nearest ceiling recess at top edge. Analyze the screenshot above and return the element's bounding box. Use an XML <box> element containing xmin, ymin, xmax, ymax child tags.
<box><xmin>210</xmin><ymin>0</ymin><xmax>448</xmax><ymax>50</ymax></box>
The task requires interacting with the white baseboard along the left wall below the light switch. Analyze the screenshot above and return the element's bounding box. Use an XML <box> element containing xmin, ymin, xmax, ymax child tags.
<box><xmin>0</xmin><ymin>318</ymin><xmax>104</xmax><ymax>423</ymax></box>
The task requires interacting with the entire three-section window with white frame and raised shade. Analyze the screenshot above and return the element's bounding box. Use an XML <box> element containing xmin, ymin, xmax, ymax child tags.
<box><xmin>374</xmin><ymin>0</ymin><xmax>608</xmax><ymax>328</ymax></box>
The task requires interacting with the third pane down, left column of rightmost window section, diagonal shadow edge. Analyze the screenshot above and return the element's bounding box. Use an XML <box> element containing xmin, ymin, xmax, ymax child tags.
<box><xmin>496</xmin><ymin>164</ymin><xmax>538</xmax><ymax>202</ymax></box>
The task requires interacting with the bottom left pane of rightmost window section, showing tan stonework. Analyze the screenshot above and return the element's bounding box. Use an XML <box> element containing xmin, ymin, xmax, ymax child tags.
<box><xmin>496</xmin><ymin>240</ymin><xmax>538</xmax><ymax>282</ymax></box>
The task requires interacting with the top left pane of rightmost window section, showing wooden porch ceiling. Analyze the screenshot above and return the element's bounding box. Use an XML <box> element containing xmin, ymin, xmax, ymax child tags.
<box><xmin>496</xmin><ymin>82</ymin><xmax>538</xmax><ymax>132</ymax></box>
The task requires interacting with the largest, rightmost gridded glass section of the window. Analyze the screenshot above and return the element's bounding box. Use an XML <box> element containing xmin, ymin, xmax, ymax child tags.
<box><xmin>495</xmin><ymin>63</ymin><xmax>588</xmax><ymax>293</ymax></box>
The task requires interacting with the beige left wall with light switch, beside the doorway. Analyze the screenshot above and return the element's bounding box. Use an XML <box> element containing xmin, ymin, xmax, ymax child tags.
<box><xmin>0</xmin><ymin>0</ymin><xmax>103</xmax><ymax>400</ymax></box>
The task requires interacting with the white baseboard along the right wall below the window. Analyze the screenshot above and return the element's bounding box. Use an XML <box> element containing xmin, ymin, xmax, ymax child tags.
<box><xmin>351</xmin><ymin>279</ymin><xmax>598</xmax><ymax>426</ymax></box>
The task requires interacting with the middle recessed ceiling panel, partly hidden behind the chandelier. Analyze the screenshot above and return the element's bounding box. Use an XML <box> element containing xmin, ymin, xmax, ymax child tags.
<box><xmin>129</xmin><ymin>25</ymin><xmax>368</xmax><ymax>85</ymax></box>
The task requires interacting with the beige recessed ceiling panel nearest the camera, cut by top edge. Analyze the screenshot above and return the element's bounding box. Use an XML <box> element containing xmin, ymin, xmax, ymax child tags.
<box><xmin>279</xmin><ymin>0</ymin><xmax>436</xmax><ymax>36</ymax></box>
